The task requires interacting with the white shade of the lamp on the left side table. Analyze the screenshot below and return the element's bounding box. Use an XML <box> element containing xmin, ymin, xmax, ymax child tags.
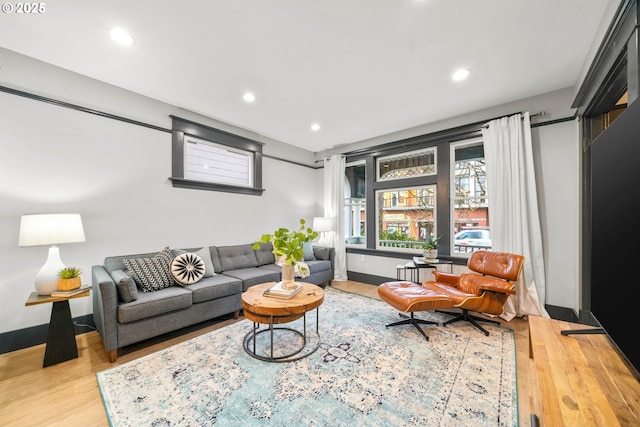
<box><xmin>18</xmin><ymin>214</ymin><xmax>85</xmax><ymax>246</ymax></box>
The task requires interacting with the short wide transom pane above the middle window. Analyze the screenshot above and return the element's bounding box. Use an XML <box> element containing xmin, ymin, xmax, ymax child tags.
<box><xmin>378</xmin><ymin>148</ymin><xmax>437</xmax><ymax>181</ymax></box>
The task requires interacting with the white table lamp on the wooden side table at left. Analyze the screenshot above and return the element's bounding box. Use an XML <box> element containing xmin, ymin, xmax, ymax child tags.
<box><xmin>18</xmin><ymin>214</ymin><xmax>85</xmax><ymax>295</ymax></box>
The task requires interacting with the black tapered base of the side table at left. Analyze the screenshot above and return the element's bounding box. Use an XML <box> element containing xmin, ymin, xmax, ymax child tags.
<box><xmin>42</xmin><ymin>300</ymin><xmax>78</xmax><ymax>368</ymax></box>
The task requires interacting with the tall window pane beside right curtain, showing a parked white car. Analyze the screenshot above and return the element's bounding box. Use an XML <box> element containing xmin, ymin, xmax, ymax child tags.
<box><xmin>451</xmin><ymin>140</ymin><xmax>491</xmax><ymax>255</ymax></box>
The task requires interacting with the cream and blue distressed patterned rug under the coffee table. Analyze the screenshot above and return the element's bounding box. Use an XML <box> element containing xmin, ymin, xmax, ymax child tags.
<box><xmin>97</xmin><ymin>288</ymin><xmax>518</xmax><ymax>427</ymax></box>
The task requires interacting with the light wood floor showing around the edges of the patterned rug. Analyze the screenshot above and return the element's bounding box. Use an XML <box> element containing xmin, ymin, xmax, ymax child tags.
<box><xmin>0</xmin><ymin>281</ymin><xmax>539</xmax><ymax>427</ymax></box>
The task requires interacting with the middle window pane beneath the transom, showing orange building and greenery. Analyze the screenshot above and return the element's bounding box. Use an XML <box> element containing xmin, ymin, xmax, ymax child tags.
<box><xmin>376</xmin><ymin>185</ymin><xmax>437</xmax><ymax>252</ymax></box>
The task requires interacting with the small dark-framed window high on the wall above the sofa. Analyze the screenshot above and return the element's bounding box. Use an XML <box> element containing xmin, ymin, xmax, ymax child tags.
<box><xmin>171</xmin><ymin>116</ymin><xmax>264</xmax><ymax>195</ymax></box>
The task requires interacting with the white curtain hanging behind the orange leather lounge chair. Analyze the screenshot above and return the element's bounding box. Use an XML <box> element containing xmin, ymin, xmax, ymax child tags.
<box><xmin>482</xmin><ymin>113</ymin><xmax>549</xmax><ymax>321</ymax></box>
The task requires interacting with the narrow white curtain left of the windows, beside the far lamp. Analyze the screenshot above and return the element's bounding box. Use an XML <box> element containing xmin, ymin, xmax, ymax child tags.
<box><xmin>324</xmin><ymin>154</ymin><xmax>347</xmax><ymax>281</ymax></box>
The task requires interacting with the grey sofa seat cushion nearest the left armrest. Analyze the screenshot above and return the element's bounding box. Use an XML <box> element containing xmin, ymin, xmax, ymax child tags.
<box><xmin>118</xmin><ymin>286</ymin><xmax>192</xmax><ymax>323</ymax></box>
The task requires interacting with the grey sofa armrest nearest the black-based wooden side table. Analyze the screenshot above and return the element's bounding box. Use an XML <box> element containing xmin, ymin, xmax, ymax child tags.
<box><xmin>91</xmin><ymin>265</ymin><xmax>118</xmax><ymax>352</ymax></box>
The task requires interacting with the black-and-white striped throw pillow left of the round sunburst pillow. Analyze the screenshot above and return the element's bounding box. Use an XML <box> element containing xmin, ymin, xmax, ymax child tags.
<box><xmin>122</xmin><ymin>246</ymin><xmax>175</xmax><ymax>292</ymax></box>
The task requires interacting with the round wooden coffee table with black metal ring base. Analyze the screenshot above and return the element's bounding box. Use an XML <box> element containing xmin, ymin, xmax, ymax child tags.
<box><xmin>242</xmin><ymin>282</ymin><xmax>324</xmax><ymax>362</ymax></box>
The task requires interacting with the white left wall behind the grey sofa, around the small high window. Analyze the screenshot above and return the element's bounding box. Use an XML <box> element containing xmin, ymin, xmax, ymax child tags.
<box><xmin>0</xmin><ymin>50</ymin><xmax>322</xmax><ymax>333</ymax></box>
